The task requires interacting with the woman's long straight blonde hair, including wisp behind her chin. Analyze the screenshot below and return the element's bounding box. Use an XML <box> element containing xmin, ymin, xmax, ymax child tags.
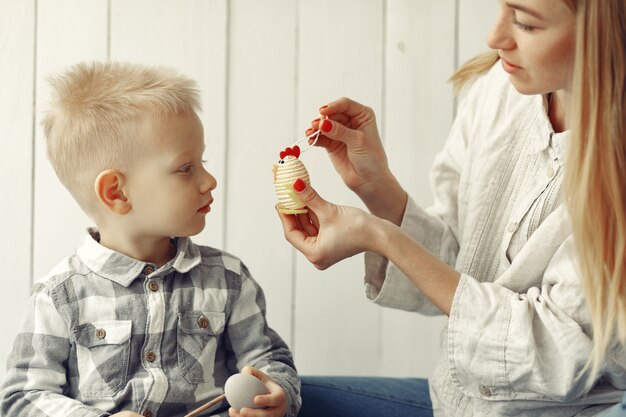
<box><xmin>450</xmin><ymin>0</ymin><xmax>626</xmax><ymax>376</ymax></box>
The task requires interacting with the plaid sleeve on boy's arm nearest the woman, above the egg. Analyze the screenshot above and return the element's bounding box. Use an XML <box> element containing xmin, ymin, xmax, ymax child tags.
<box><xmin>226</xmin><ymin>267</ymin><xmax>302</xmax><ymax>416</ymax></box>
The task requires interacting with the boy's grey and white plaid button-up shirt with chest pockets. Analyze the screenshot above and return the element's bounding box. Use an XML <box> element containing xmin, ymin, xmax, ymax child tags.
<box><xmin>0</xmin><ymin>231</ymin><xmax>301</xmax><ymax>417</ymax></box>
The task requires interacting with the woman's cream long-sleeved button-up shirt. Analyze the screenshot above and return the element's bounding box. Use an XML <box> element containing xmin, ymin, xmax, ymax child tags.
<box><xmin>365</xmin><ymin>63</ymin><xmax>626</xmax><ymax>417</ymax></box>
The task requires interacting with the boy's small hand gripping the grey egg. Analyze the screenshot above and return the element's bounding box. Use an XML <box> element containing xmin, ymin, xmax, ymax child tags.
<box><xmin>228</xmin><ymin>366</ymin><xmax>287</xmax><ymax>417</ymax></box>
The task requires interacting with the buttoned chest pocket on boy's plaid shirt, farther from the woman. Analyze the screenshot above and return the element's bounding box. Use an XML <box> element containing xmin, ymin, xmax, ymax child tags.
<box><xmin>74</xmin><ymin>320</ymin><xmax>132</xmax><ymax>397</ymax></box>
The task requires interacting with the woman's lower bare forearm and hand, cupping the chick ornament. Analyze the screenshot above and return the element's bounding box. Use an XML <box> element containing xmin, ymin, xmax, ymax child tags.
<box><xmin>279</xmin><ymin>180</ymin><xmax>460</xmax><ymax>314</ymax></box>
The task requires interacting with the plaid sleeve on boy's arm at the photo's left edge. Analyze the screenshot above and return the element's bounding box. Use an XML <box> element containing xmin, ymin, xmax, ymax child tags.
<box><xmin>0</xmin><ymin>284</ymin><xmax>109</xmax><ymax>417</ymax></box>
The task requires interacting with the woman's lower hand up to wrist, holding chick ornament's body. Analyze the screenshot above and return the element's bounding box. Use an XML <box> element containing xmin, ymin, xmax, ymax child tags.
<box><xmin>278</xmin><ymin>180</ymin><xmax>380</xmax><ymax>269</ymax></box>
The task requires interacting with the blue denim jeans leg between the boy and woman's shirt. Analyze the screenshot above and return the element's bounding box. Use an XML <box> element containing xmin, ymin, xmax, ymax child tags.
<box><xmin>298</xmin><ymin>376</ymin><xmax>433</xmax><ymax>417</ymax></box>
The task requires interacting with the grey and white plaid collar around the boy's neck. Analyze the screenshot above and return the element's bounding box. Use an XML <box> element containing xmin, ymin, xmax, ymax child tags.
<box><xmin>76</xmin><ymin>228</ymin><xmax>202</xmax><ymax>287</ymax></box>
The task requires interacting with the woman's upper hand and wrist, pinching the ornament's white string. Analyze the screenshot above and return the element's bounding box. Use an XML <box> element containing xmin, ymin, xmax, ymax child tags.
<box><xmin>307</xmin><ymin>98</ymin><xmax>407</xmax><ymax>224</ymax></box>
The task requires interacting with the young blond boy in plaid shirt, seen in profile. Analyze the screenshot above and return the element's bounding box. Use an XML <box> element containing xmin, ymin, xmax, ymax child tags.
<box><xmin>0</xmin><ymin>63</ymin><xmax>300</xmax><ymax>417</ymax></box>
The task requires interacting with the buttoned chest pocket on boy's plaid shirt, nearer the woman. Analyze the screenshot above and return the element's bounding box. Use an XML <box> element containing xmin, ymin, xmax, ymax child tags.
<box><xmin>176</xmin><ymin>311</ymin><xmax>226</xmax><ymax>384</ymax></box>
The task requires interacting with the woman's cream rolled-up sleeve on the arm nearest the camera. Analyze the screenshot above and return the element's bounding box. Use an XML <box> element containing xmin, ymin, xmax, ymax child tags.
<box><xmin>447</xmin><ymin>210</ymin><xmax>626</xmax><ymax>402</ymax></box>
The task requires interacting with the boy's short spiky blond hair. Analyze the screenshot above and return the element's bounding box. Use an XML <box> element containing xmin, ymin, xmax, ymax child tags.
<box><xmin>42</xmin><ymin>62</ymin><xmax>200</xmax><ymax>217</ymax></box>
